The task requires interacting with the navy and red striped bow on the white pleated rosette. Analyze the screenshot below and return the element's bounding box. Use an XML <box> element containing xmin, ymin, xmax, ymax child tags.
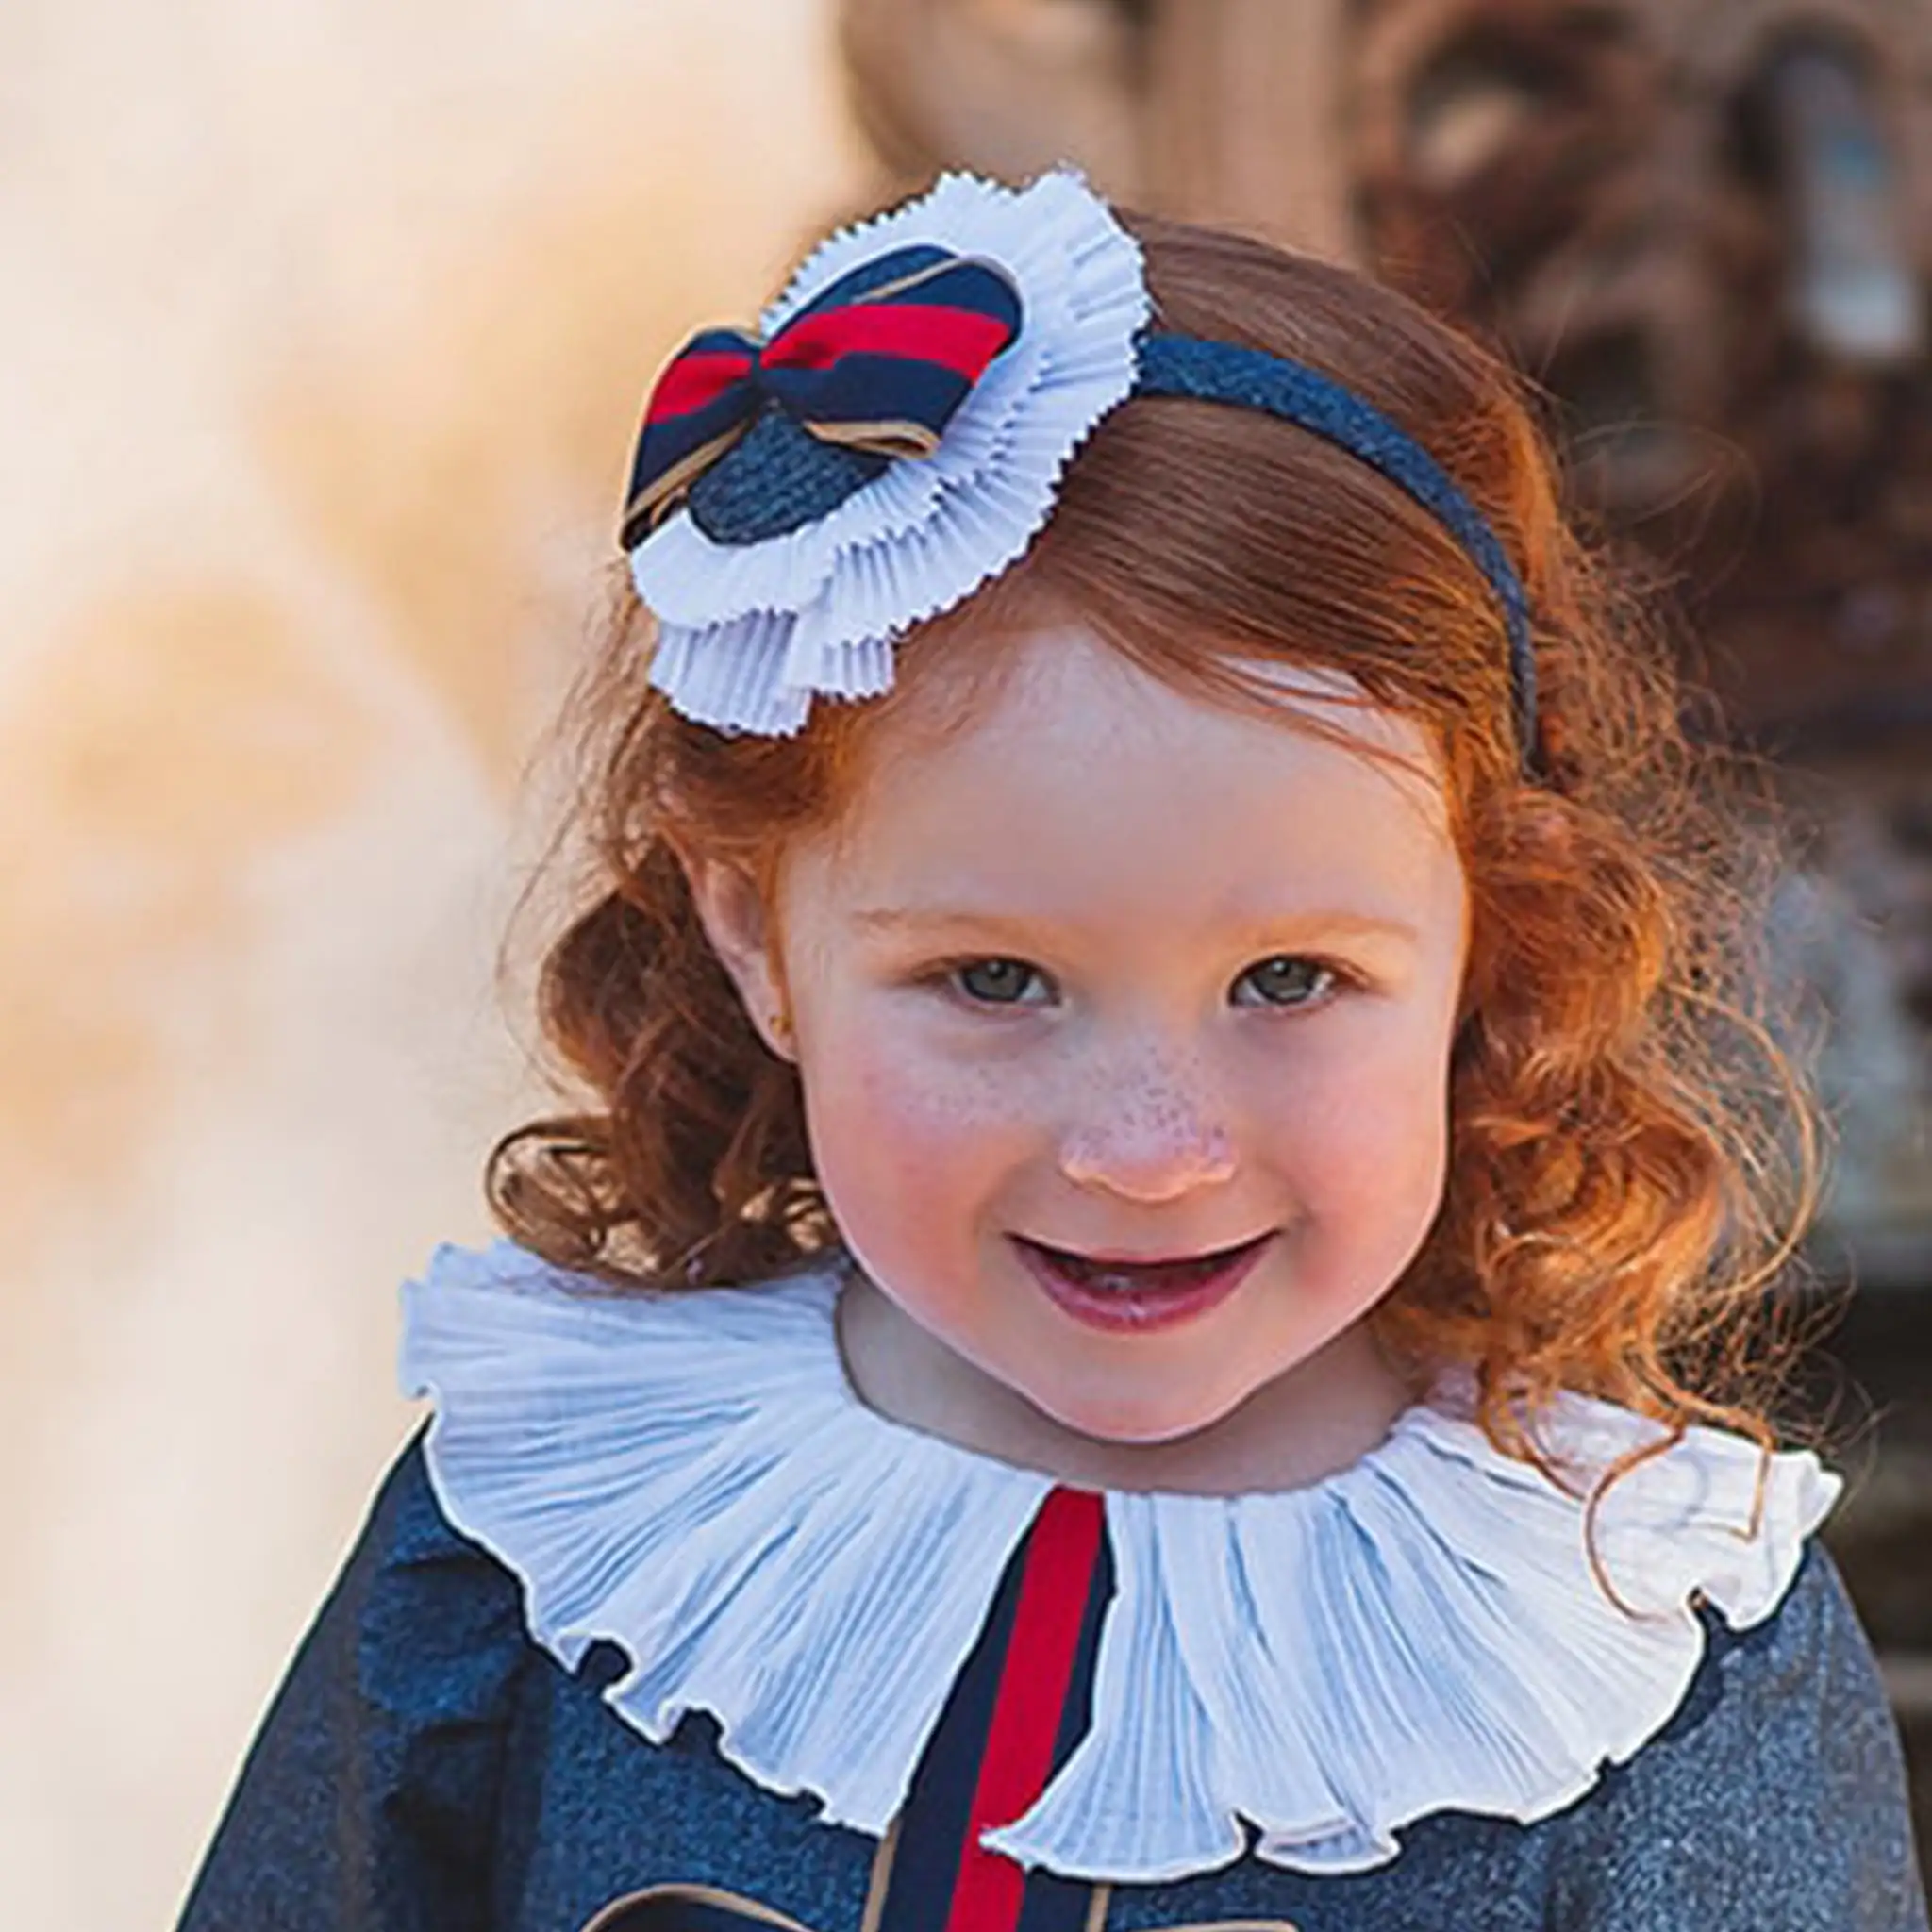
<box><xmin>622</xmin><ymin>243</ymin><xmax>1020</xmax><ymax>551</ymax></box>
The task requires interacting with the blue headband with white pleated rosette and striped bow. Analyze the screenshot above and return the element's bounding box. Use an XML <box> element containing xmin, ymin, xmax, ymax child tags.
<box><xmin>622</xmin><ymin>168</ymin><xmax>1540</xmax><ymax>774</ymax></box>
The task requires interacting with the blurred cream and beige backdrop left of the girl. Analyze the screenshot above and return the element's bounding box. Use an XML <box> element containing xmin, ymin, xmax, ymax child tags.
<box><xmin>0</xmin><ymin>0</ymin><xmax>863</xmax><ymax>1932</ymax></box>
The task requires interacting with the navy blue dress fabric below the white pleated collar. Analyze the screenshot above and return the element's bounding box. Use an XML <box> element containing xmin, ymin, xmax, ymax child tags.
<box><xmin>179</xmin><ymin>1445</ymin><xmax>1926</xmax><ymax>1932</ymax></box>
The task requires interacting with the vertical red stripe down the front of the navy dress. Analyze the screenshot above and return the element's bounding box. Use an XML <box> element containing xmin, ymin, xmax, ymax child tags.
<box><xmin>944</xmin><ymin>1490</ymin><xmax>1105</xmax><ymax>1932</ymax></box>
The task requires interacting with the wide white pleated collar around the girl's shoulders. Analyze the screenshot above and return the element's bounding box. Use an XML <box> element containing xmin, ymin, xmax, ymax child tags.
<box><xmin>402</xmin><ymin>1242</ymin><xmax>1840</xmax><ymax>1882</ymax></box>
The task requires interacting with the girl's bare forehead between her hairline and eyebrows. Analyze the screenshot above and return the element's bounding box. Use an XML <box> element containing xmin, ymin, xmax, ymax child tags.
<box><xmin>791</xmin><ymin>625</ymin><xmax>1453</xmax><ymax>915</ymax></box>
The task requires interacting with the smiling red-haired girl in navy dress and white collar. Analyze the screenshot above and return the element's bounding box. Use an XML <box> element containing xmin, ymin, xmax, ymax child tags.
<box><xmin>184</xmin><ymin>174</ymin><xmax>1926</xmax><ymax>1932</ymax></box>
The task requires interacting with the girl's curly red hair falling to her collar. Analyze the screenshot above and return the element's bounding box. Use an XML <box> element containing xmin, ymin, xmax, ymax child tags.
<box><xmin>487</xmin><ymin>204</ymin><xmax>1818</xmax><ymax>1462</ymax></box>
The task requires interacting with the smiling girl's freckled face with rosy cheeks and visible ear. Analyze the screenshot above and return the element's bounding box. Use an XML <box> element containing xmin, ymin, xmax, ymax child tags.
<box><xmin>693</xmin><ymin>630</ymin><xmax>1466</xmax><ymax>1443</ymax></box>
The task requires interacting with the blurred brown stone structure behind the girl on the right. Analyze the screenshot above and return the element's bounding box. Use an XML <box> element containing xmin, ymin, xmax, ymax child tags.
<box><xmin>842</xmin><ymin>0</ymin><xmax>1932</xmax><ymax>1864</ymax></box>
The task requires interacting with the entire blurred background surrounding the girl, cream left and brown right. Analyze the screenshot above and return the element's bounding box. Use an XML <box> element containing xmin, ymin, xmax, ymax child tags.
<box><xmin>0</xmin><ymin>0</ymin><xmax>1932</xmax><ymax>1932</ymax></box>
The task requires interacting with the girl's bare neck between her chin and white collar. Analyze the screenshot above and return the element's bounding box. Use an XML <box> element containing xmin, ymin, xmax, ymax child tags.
<box><xmin>839</xmin><ymin>1267</ymin><xmax>1416</xmax><ymax>1495</ymax></box>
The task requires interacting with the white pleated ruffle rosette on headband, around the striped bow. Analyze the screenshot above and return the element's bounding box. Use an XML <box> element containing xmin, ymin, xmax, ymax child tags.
<box><xmin>632</xmin><ymin>170</ymin><xmax>1148</xmax><ymax>732</ymax></box>
